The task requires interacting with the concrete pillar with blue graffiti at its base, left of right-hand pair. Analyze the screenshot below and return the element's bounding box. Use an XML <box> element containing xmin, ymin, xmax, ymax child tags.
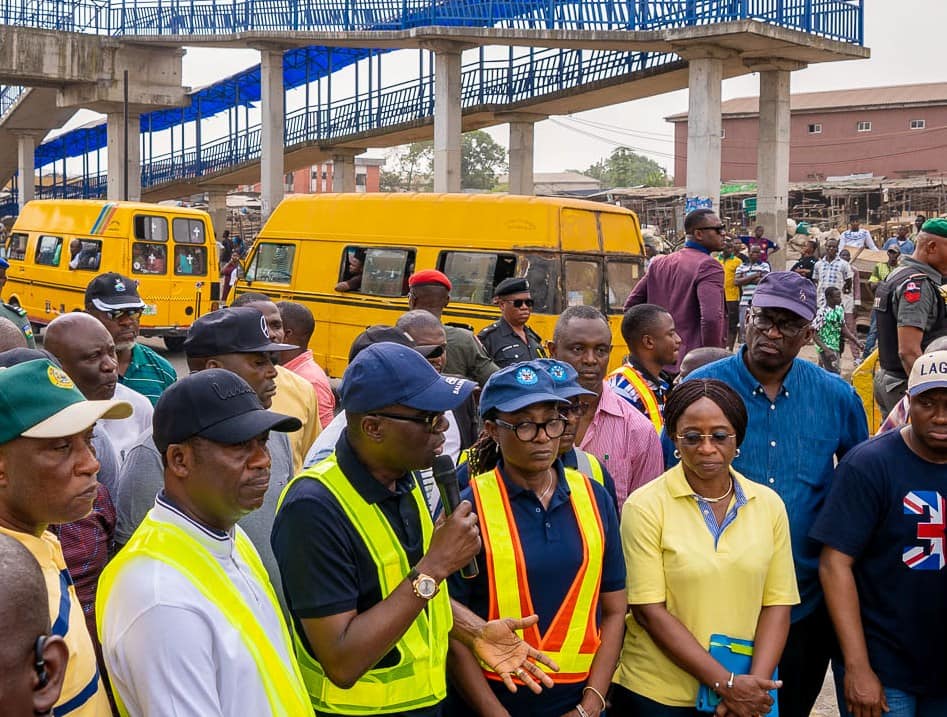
<box><xmin>687</xmin><ymin>56</ymin><xmax>723</xmax><ymax>209</ymax></box>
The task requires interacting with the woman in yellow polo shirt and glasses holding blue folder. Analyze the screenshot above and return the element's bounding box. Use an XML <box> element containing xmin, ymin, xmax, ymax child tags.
<box><xmin>612</xmin><ymin>379</ymin><xmax>799</xmax><ymax>717</ymax></box>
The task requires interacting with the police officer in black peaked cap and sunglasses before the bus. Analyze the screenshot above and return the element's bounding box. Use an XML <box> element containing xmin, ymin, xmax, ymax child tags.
<box><xmin>478</xmin><ymin>277</ymin><xmax>546</xmax><ymax>368</ymax></box>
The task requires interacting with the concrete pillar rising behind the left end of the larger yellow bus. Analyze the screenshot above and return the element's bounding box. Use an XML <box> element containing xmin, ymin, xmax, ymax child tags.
<box><xmin>260</xmin><ymin>49</ymin><xmax>286</xmax><ymax>219</ymax></box>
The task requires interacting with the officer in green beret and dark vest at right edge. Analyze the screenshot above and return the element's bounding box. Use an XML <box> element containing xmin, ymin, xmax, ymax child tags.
<box><xmin>874</xmin><ymin>219</ymin><xmax>947</xmax><ymax>413</ymax></box>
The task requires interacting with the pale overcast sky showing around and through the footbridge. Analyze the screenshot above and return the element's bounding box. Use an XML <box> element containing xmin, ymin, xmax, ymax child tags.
<box><xmin>61</xmin><ymin>0</ymin><xmax>947</xmax><ymax>178</ymax></box>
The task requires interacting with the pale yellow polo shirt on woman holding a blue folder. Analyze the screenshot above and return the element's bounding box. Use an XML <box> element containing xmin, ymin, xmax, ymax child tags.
<box><xmin>615</xmin><ymin>464</ymin><xmax>799</xmax><ymax>707</ymax></box>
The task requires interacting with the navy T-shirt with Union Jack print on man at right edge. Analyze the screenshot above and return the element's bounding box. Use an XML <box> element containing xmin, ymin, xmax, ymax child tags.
<box><xmin>810</xmin><ymin>431</ymin><xmax>947</xmax><ymax>697</ymax></box>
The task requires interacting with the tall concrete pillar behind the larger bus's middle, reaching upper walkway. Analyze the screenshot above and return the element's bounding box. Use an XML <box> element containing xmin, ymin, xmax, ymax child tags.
<box><xmin>434</xmin><ymin>44</ymin><xmax>462</xmax><ymax>192</ymax></box>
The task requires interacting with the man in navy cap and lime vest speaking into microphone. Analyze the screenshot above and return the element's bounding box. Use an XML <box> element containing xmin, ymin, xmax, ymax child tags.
<box><xmin>272</xmin><ymin>342</ymin><xmax>554</xmax><ymax>717</ymax></box>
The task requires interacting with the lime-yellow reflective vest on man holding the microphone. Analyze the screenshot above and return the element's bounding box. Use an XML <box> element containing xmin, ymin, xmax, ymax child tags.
<box><xmin>276</xmin><ymin>453</ymin><xmax>454</xmax><ymax>715</ymax></box>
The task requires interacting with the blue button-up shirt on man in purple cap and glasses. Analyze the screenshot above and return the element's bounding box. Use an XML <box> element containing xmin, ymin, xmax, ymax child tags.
<box><xmin>684</xmin><ymin>348</ymin><xmax>868</xmax><ymax>621</ymax></box>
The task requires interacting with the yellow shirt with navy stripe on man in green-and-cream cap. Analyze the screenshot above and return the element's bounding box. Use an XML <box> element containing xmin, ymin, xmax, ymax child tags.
<box><xmin>0</xmin><ymin>527</ymin><xmax>112</xmax><ymax>717</ymax></box>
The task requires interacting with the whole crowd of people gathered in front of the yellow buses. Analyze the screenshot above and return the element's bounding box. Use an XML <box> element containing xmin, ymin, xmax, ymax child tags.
<box><xmin>0</xmin><ymin>210</ymin><xmax>947</xmax><ymax>717</ymax></box>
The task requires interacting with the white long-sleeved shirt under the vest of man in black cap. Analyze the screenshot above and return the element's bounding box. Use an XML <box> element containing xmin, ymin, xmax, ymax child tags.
<box><xmin>100</xmin><ymin>496</ymin><xmax>292</xmax><ymax>717</ymax></box>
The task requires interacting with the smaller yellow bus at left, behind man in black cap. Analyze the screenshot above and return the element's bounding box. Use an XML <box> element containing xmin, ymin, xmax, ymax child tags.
<box><xmin>6</xmin><ymin>199</ymin><xmax>219</xmax><ymax>349</ymax></box>
